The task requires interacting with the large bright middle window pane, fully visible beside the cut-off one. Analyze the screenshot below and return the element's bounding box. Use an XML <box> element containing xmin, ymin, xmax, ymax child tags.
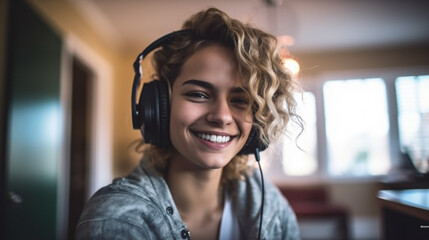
<box><xmin>323</xmin><ymin>78</ymin><xmax>390</xmax><ymax>176</ymax></box>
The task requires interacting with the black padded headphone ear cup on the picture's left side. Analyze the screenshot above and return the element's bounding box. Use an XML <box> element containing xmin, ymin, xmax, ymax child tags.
<box><xmin>138</xmin><ymin>80</ymin><xmax>170</xmax><ymax>147</ymax></box>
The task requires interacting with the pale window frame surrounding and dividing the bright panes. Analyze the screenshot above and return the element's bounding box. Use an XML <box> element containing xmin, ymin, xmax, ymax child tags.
<box><xmin>273</xmin><ymin>66</ymin><xmax>429</xmax><ymax>185</ymax></box>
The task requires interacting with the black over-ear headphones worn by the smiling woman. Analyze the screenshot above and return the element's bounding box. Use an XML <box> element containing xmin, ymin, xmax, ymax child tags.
<box><xmin>131</xmin><ymin>30</ymin><xmax>267</xmax><ymax>154</ymax></box>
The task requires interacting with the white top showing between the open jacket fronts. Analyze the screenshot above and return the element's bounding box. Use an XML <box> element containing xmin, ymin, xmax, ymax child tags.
<box><xmin>219</xmin><ymin>195</ymin><xmax>240</xmax><ymax>240</ymax></box>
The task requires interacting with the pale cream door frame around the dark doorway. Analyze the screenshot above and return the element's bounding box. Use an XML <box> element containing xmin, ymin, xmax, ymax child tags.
<box><xmin>57</xmin><ymin>34</ymin><xmax>113</xmax><ymax>239</ymax></box>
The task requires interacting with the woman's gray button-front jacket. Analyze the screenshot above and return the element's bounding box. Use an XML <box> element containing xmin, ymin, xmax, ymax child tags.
<box><xmin>76</xmin><ymin>161</ymin><xmax>299</xmax><ymax>240</ymax></box>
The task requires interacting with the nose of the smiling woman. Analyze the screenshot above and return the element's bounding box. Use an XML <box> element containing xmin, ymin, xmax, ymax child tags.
<box><xmin>207</xmin><ymin>99</ymin><xmax>233</xmax><ymax>127</ymax></box>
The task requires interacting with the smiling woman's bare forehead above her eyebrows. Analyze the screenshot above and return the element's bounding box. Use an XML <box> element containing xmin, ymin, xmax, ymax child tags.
<box><xmin>174</xmin><ymin>44</ymin><xmax>242</xmax><ymax>86</ymax></box>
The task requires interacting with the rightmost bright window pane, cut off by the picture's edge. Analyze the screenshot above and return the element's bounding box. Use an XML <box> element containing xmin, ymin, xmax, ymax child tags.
<box><xmin>395</xmin><ymin>76</ymin><xmax>429</xmax><ymax>172</ymax></box>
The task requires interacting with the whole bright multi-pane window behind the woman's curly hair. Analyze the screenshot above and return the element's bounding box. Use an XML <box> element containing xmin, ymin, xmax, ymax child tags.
<box><xmin>267</xmin><ymin>70</ymin><xmax>429</xmax><ymax>181</ymax></box>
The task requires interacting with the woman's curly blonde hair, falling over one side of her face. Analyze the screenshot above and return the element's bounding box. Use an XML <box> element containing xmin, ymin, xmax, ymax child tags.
<box><xmin>143</xmin><ymin>8</ymin><xmax>301</xmax><ymax>183</ymax></box>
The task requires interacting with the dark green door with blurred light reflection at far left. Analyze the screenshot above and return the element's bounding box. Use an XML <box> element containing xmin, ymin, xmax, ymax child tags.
<box><xmin>6</xmin><ymin>0</ymin><xmax>64</xmax><ymax>239</ymax></box>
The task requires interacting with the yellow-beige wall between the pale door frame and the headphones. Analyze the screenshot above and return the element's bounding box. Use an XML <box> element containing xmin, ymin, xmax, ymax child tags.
<box><xmin>27</xmin><ymin>0</ymin><xmax>147</xmax><ymax>176</ymax></box>
